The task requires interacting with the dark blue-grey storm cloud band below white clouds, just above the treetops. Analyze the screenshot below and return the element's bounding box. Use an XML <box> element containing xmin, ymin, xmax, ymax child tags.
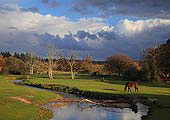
<box><xmin>0</xmin><ymin>25</ymin><xmax>170</xmax><ymax>60</ymax></box>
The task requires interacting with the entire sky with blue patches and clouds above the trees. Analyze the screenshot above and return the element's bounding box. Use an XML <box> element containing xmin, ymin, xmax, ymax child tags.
<box><xmin>0</xmin><ymin>0</ymin><xmax>170</xmax><ymax>60</ymax></box>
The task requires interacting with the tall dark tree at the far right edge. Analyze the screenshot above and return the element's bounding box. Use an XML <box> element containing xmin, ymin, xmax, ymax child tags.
<box><xmin>143</xmin><ymin>39</ymin><xmax>170</xmax><ymax>81</ymax></box>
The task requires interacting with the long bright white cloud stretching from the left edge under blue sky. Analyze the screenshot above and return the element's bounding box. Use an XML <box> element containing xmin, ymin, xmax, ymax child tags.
<box><xmin>0</xmin><ymin>10</ymin><xmax>107</xmax><ymax>37</ymax></box>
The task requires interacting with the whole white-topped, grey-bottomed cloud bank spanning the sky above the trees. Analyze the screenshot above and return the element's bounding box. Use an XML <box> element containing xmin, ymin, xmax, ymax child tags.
<box><xmin>0</xmin><ymin>3</ymin><xmax>170</xmax><ymax>60</ymax></box>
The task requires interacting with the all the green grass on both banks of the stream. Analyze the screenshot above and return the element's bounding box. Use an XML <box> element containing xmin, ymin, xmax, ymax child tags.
<box><xmin>0</xmin><ymin>75</ymin><xmax>170</xmax><ymax>120</ymax></box>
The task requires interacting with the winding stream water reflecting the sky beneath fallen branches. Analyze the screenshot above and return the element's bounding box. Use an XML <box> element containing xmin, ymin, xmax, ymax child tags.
<box><xmin>14</xmin><ymin>80</ymin><xmax>148</xmax><ymax>120</ymax></box>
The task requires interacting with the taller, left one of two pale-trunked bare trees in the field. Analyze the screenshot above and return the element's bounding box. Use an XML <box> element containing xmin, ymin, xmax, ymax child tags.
<box><xmin>47</xmin><ymin>44</ymin><xmax>57</xmax><ymax>79</ymax></box>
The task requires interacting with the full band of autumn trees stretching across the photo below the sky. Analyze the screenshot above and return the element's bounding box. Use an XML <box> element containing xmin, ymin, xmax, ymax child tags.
<box><xmin>0</xmin><ymin>40</ymin><xmax>170</xmax><ymax>82</ymax></box>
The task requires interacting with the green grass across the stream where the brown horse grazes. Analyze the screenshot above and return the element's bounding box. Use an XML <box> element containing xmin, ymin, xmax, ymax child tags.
<box><xmin>25</xmin><ymin>75</ymin><xmax>170</xmax><ymax>120</ymax></box>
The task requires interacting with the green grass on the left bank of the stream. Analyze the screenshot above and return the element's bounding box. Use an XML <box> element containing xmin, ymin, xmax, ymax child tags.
<box><xmin>0</xmin><ymin>75</ymin><xmax>60</xmax><ymax>120</ymax></box>
